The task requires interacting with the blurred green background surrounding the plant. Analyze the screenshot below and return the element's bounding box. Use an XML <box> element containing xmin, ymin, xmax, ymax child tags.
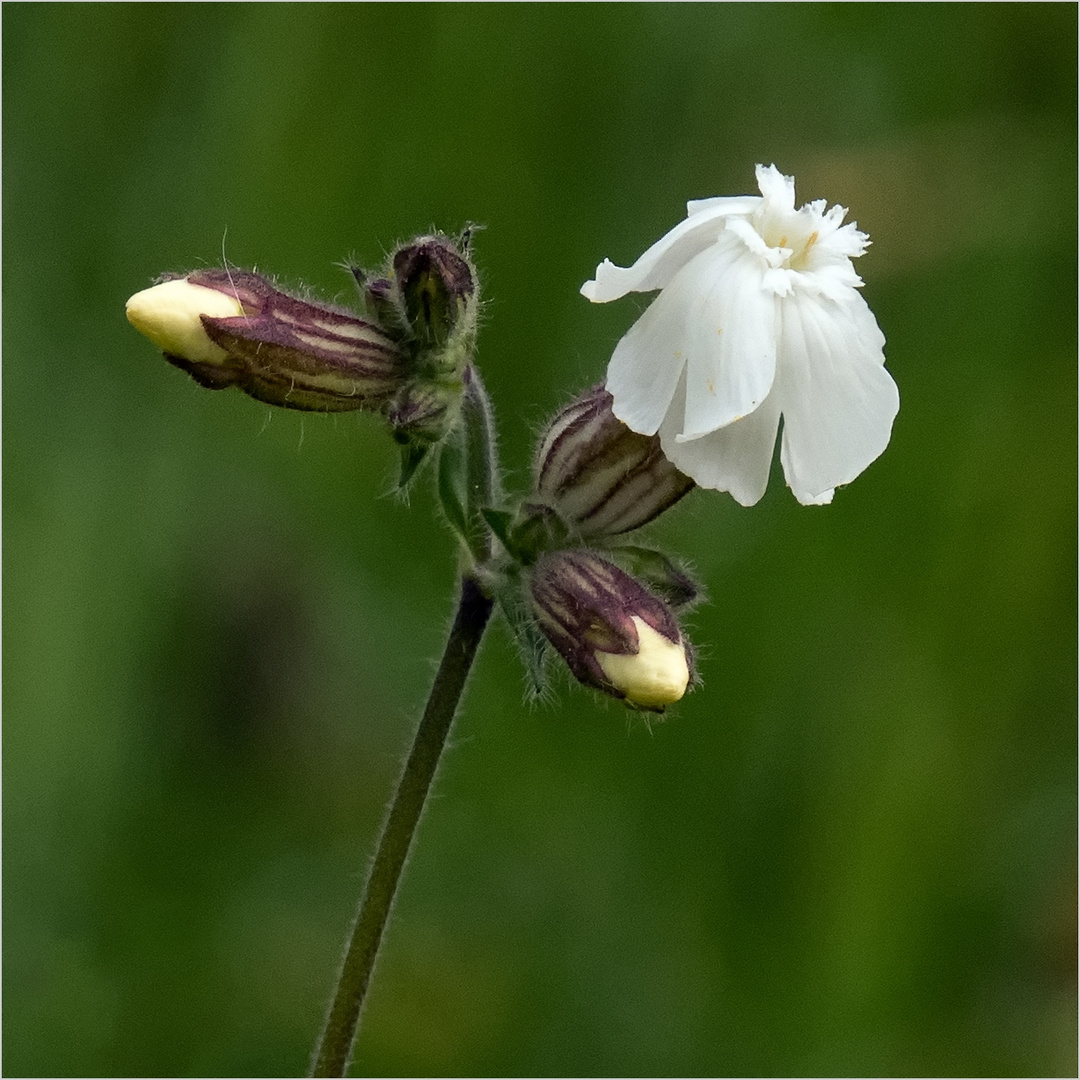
<box><xmin>3</xmin><ymin>4</ymin><xmax>1077</xmax><ymax>1076</ymax></box>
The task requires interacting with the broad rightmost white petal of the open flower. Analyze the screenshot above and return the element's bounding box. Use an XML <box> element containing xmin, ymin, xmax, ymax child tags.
<box><xmin>777</xmin><ymin>293</ymin><xmax>900</xmax><ymax>503</ymax></box>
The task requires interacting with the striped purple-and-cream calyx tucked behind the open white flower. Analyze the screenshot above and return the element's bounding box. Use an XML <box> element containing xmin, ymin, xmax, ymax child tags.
<box><xmin>530</xmin><ymin>386</ymin><xmax>693</xmax><ymax>539</ymax></box>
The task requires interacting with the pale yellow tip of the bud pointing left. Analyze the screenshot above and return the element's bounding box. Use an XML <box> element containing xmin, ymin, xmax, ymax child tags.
<box><xmin>127</xmin><ymin>278</ymin><xmax>244</xmax><ymax>364</ymax></box>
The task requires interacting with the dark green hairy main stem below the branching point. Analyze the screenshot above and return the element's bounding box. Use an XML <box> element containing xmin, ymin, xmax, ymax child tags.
<box><xmin>310</xmin><ymin>577</ymin><xmax>491</xmax><ymax>1077</ymax></box>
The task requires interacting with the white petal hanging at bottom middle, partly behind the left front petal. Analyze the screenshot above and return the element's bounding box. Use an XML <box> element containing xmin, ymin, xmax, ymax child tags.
<box><xmin>660</xmin><ymin>369</ymin><xmax>780</xmax><ymax>507</ymax></box>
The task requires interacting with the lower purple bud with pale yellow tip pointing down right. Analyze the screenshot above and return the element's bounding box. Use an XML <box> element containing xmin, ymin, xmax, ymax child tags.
<box><xmin>529</xmin><ymin>550</ymin><xmax>690</xmax><ymax>713</ymax></box>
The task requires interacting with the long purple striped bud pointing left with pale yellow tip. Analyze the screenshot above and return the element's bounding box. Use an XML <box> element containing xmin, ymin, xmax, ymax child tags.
<box><xmin>127</xmin><ymin>270</ymin><xmax>408</xmax><ymax>413</ymax></box>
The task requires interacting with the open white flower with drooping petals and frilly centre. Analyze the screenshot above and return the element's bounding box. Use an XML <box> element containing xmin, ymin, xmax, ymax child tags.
<box><xmin>581</xmin><ymin>165</ymin><xmax>900</xmax><ymax>507</ymax></box>
